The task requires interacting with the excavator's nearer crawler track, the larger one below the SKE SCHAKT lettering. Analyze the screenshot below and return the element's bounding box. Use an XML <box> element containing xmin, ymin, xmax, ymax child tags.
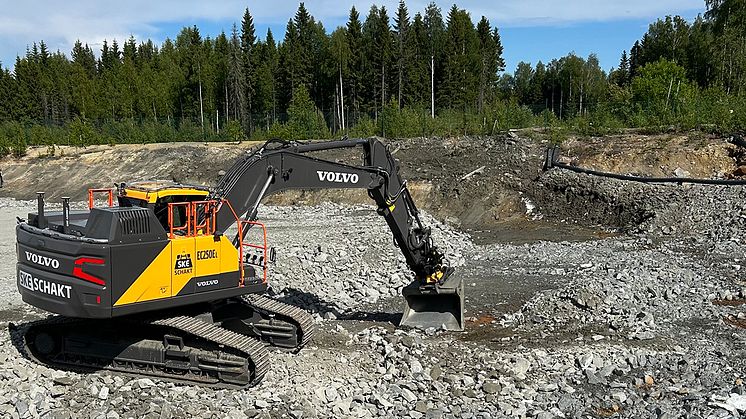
<box><xmin>11</xmin><ymin>316</ymin><xmax>270</xmax><ymax>388</ymax></box>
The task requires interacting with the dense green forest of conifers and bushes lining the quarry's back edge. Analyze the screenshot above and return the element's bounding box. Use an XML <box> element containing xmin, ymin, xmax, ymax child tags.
<box><xmin>0</xmin><ymin>0</ymin><xmax>746</xmax><ymax>143</ymax></box>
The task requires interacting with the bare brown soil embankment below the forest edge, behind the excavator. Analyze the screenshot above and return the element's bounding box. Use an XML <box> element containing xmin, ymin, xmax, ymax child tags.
<box><xmin>0</xmin><ymin>131</ymin><xmax>741</xmax><ymax>235</ymax></box>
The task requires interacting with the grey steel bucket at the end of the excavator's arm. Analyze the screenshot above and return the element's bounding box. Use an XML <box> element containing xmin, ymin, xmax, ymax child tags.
<box><xmin>399</xmin><ymin>275</ymin><xmax>464</xmax><ymax>332</ymax></box>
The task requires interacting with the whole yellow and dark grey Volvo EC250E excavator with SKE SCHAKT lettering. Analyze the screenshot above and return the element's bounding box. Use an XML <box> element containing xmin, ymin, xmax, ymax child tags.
<box><xmin>13</xmin><ymin>138</ymin><xmax>464</xmax><ymax>388</ymax></box>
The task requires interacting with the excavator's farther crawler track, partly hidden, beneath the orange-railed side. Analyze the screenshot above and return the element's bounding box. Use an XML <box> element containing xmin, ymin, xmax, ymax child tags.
<box><xmin>241</xmin><ymin>294</ymin><xmax>316</xmax><ymax>351</ymax></box>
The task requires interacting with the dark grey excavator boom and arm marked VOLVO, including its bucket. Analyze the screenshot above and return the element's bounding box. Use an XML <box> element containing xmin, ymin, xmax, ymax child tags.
<box><xmin>209</xmin><ymin>138</ymin><xmax>463</xmax><ymax>330</ymax></box>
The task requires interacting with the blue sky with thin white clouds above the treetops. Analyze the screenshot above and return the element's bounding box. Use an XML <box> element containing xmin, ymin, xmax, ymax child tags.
<box><xmin>0</xmin><ymin>0</ymin><xmax>704</xmax><ymax>72</ymax></box>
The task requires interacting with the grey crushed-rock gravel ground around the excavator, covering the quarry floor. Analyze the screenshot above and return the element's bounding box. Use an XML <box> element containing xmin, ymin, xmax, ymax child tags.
<box><xmin>0</xmin><ymin>167</ymin><xmax>746</xmax><ymax>418</ymax></box>
